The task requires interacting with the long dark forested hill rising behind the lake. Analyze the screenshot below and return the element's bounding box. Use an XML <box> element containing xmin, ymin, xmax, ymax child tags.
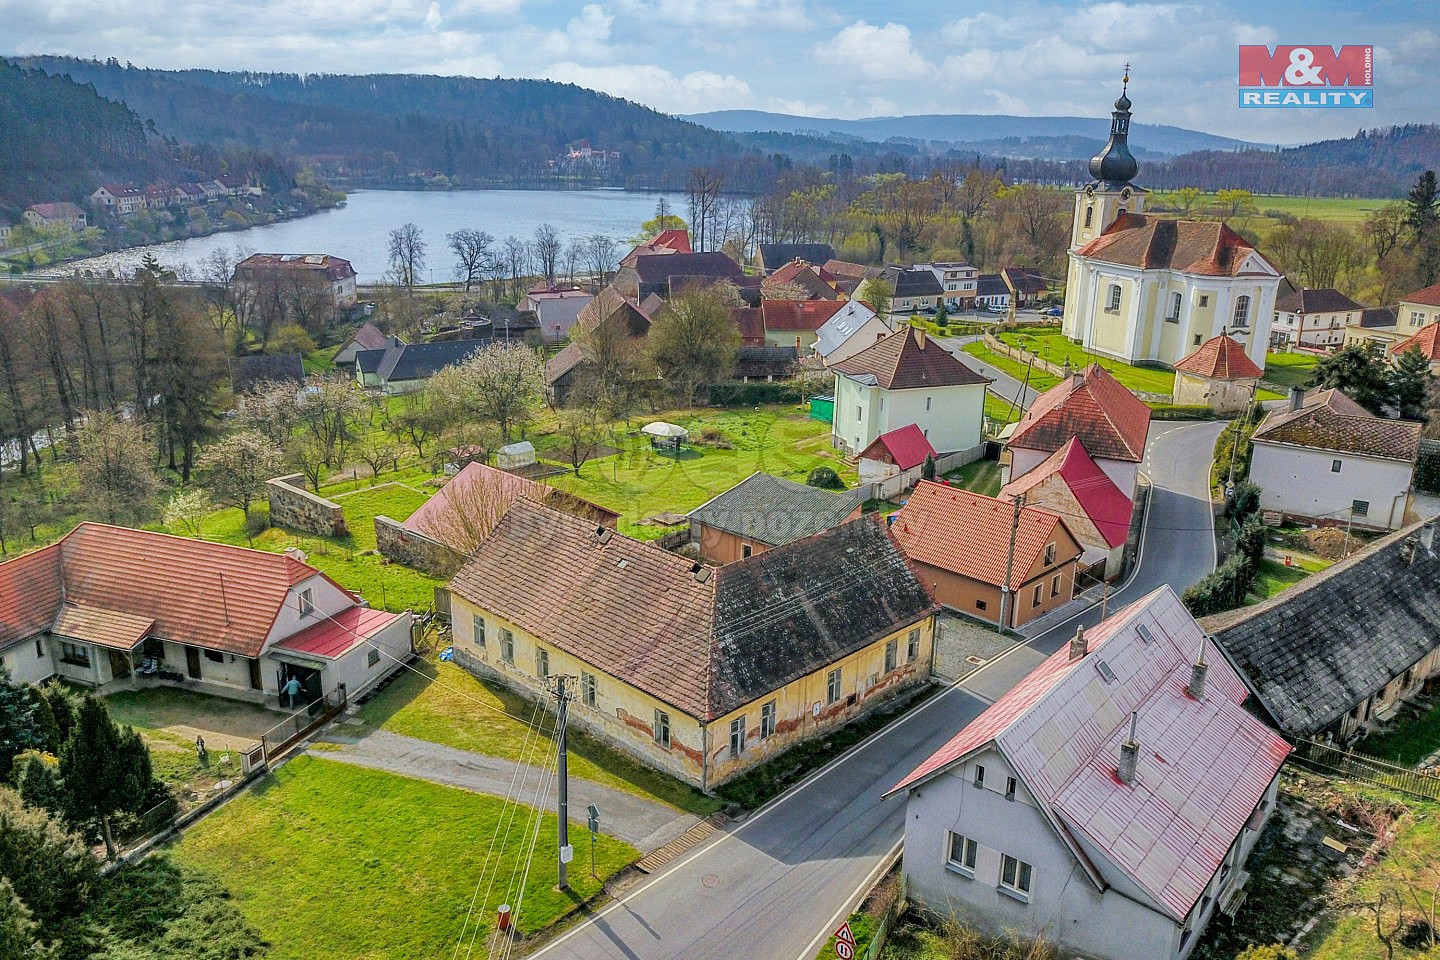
<box><xmin>16</xmin><ymin>58</ymin><xmax>759</xmax><ymax>187</ymax></box>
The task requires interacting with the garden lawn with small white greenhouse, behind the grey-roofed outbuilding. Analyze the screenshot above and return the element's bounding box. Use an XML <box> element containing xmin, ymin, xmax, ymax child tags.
<box><xmin>546</xmin><ymin>406</ymin><xmax>855</xmax><ymax>540</ymax></box>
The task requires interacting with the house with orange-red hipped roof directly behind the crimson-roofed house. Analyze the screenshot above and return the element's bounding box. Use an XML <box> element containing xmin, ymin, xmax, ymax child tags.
<box><xmin>1001</xmin><ymin>364</ymin><xmax>1151</xmax><ymax>499</ymax></box>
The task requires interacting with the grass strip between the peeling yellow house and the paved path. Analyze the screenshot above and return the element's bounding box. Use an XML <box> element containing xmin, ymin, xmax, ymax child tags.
<box><xmin>359</xmin><ymin>661</ymin><xmax>720</xmax><ymax>816</ymax></box>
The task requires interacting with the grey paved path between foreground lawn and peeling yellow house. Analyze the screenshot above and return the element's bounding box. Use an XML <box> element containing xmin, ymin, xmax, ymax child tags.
<box><xmin>305</xmin><ymin>725</ymin><xmax>700</xmax><ymax>853</ymax></box>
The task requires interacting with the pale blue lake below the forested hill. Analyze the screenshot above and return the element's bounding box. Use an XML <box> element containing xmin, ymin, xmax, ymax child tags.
<box><xmin>40</xmin><ymin>190</ymin><xmax>685</xmax><ymax>284</ymax></box>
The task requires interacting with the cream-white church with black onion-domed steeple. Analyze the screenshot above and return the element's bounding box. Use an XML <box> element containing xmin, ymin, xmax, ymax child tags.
<box><xmin>1061</xmin><ymin>73</ymin><xmax>1282</xmax><ymax>368</ymax></box>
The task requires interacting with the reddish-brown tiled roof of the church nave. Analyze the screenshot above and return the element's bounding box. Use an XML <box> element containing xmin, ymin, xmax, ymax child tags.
<box><xmin>1077</xmin><ymin>213</ymin><xmax>1272</xmax><ymax>276</ymax></box>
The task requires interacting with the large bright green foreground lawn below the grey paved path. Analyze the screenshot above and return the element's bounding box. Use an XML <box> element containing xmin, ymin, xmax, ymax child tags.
<box><xmin>174</xmin><ymin>756</ymin><xmax>639</xmax><ymax>960</ymax></box>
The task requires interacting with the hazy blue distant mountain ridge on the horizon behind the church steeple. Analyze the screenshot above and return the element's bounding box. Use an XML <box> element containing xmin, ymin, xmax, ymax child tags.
<box><xmin>684</xmin><ymin>109</ymin><xmax>1263</xmax><ymax>158</ymax></box>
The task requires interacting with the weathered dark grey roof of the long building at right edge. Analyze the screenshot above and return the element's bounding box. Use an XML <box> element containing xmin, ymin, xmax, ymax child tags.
<box><xmin>1200</xmin><ymin>524</ymin><xmax>1440</xmax><ymax>737</ymax></box>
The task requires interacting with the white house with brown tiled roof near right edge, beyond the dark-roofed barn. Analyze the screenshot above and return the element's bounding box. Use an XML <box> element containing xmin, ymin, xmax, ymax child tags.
<box><xmin>1250</xmin><ymin>389</ymin><xmax>1421</xmax><ymax>530</ymax></box>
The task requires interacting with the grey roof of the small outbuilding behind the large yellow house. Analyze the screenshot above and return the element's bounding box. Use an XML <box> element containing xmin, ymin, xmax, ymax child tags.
<box><xmin>690</xmin><ymin>474</ymin><xmax>860</xmax><ymax>547</ymax></box>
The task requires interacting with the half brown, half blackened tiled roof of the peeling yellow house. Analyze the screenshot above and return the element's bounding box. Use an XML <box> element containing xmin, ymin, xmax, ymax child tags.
<box><xmin>449</xmin><ymin>499</ymin><xmax>935</xmax><ymax>720</ymax></box>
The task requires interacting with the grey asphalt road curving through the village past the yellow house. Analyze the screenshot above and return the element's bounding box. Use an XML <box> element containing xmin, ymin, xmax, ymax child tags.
<box><xmin>531</xmin><ymin>422</ymin><xmax>1221</xmax><ymax>960</ymax></box>
